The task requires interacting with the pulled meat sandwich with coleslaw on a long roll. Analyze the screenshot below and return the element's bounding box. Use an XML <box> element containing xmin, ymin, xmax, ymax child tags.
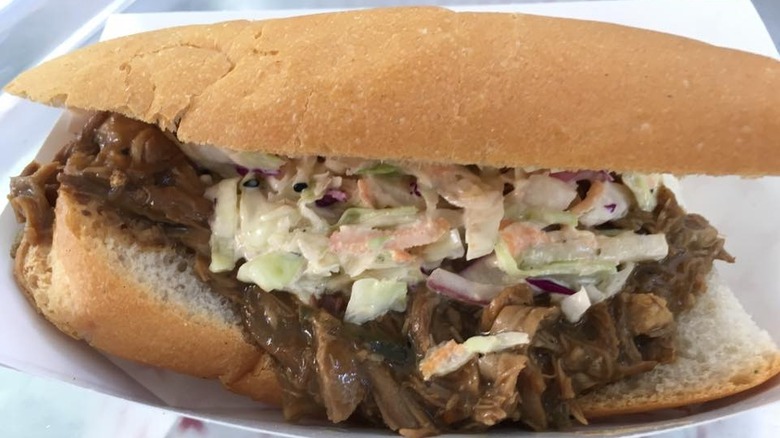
<box><xmin>6</xmin><ymin>8</ymin><xmax>780</xmax><ymax>436</ymax></box>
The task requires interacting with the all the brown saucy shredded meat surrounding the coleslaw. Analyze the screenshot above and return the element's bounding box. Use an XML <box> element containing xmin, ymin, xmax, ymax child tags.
<box><xmin>10</xmin><ymin>114</ymin><xmax>731</xmax><ymax>437</ymax></box>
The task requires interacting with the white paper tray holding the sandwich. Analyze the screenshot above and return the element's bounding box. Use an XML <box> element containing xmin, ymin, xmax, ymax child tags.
<box><xmin>0</xmin><ymin>0</ymin><xmax>780</xmax><ymax>437</ymax></box>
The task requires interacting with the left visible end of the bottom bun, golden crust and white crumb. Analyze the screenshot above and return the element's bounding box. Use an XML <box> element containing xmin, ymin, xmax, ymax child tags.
<box><xmin>14</xmin><ymin>190</ymin><xmax>281</xmax><ymax>405</ymax></box>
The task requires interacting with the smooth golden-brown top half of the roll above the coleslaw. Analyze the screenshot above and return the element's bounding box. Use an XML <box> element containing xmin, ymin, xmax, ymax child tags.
<box><xmin>6</xmin><ymin>8</ymin><xmax>780</xmax><ymax>176</ymax></box>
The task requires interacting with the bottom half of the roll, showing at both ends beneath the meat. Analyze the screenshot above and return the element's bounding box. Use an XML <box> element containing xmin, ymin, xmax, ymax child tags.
<box><xmin>15</xmin><ymin>192</ymin><xmax>780</xmax><ymax>417</ymax></box>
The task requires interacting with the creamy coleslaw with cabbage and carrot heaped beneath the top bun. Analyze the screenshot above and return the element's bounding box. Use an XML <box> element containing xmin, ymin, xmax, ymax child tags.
<box><xmin>198</xmin><ymin>151</ymin><xmax>668</xmax><ymax>324</ymax></box>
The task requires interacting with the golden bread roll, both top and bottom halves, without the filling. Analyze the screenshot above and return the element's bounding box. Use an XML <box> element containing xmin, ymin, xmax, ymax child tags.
<box><xmin>6</xmin><ymin>8</ymin><xmax>780</xmax><ymax>432</ymax></box>
